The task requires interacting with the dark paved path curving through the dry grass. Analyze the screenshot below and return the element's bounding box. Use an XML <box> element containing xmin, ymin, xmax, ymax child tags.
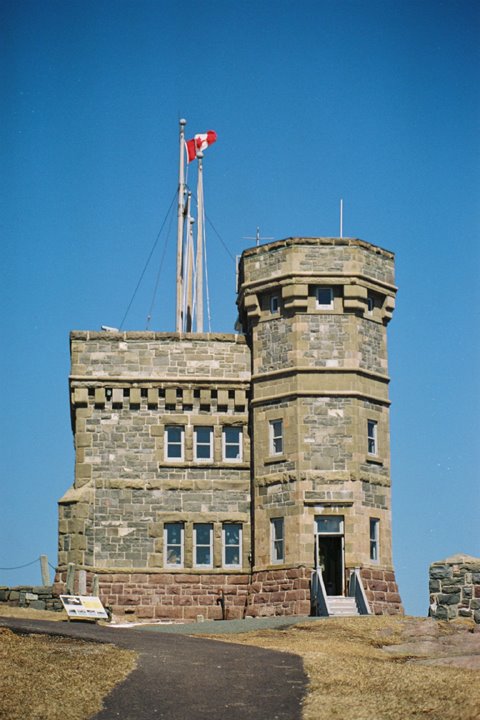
<box><xmin>0</xmin><ymin>618</ymin><xmax>307</xmax><ymax>720</ymax></box>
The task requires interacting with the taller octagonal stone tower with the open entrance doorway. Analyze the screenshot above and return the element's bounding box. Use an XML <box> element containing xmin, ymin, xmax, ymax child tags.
<box><xmin>238</xmin><ymin>238</ymin><xmax>401</xmax><ymax>613</ymax></box>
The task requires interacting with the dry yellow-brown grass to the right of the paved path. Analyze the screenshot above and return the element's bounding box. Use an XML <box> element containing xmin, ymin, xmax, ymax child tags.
<box><xmin>208</xmin><ymin>617</ymin><xmax>480</xmax><ymax>720</ymax></box>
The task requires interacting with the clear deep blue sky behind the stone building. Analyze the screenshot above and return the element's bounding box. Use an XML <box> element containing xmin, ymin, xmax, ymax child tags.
<box><xmin>0</xmin><ymin>0</ymin><xmax>480</xmax><ymax>615</ymax></box>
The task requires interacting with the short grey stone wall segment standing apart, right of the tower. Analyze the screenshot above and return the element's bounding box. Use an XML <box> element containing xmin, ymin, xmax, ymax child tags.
<box><xmin>429</xmin><ymin>555</ymin><xmax>480</xmax><ymax>623</ymax></box>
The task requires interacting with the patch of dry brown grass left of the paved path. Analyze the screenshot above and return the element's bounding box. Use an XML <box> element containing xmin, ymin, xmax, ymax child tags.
<box><xmin>0</xmin><ymin>620</ymin><xmax>137</xmax><ymax>720</ymax></box>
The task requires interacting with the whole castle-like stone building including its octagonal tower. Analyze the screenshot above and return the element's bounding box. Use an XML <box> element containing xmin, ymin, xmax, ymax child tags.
<box><xmin>57</xmin><ymin>238</ymin><xmax>402</xmax><ymax>619</ymax></box>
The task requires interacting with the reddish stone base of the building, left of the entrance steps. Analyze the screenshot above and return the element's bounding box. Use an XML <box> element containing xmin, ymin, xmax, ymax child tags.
<box><xmin>55</xmin><ymin>567</ymin><xmax>310</xmax><ymax>622</ymax></box>
